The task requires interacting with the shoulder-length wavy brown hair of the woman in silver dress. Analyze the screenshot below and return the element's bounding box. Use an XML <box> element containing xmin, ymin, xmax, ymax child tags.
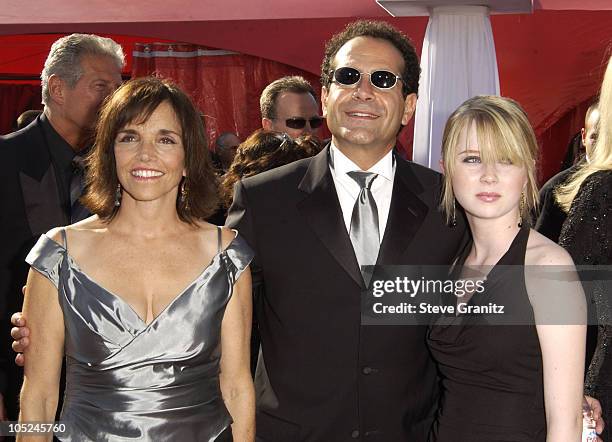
<box><xmin>81</xmin><ymin>77</ymin><xmax>219</xmax><ymax>224</ymax></box>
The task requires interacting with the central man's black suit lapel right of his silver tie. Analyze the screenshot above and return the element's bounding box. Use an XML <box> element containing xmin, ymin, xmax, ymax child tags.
<box><xmin>376</xmin><ymin>157</ymin><xmax>429</xmax><ymax>265</ymax></box>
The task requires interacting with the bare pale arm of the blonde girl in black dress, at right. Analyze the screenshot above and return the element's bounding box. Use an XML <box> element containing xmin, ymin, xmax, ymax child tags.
<box><xmin>525</xmin><ymin>244</ymin><xmax>586</xmax><ymax>442</ymax></box>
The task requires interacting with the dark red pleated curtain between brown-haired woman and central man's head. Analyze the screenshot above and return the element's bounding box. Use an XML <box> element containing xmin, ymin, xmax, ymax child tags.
<box><xmin>132</xmin><ymin>43</ymin><xmax>328</xmax><ymax>145</ymax></box>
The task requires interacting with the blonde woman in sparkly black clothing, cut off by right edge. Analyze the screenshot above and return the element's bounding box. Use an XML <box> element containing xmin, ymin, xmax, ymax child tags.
<box><xmin>556</xmin><ymin>56</ymin><xmax>612</xmax><ymax>441</ymax></box>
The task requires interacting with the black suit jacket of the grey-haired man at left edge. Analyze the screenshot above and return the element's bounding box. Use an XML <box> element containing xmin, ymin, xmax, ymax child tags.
<box><xmin>0</xmin><ymin>117</ymin><xmax>69</xmax><ymax>419</ymax></box>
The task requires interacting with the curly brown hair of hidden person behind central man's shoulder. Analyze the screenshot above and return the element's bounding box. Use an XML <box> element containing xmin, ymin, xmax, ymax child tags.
<box><xmin>221</xmin><ymin>129</ymin><xmax>321</xmax><ymax>207</ymax></box>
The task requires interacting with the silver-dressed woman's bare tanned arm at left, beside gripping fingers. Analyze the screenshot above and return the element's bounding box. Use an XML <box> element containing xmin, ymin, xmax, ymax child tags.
<box><xmin>17</xmin><ymin>269</ymin><xmax>64</xmax><ymax>442</ymax></box>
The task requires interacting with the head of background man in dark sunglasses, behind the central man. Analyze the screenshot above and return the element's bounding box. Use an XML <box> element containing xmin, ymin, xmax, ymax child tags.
<box><xmin>259</xmin><ymin>75</ymin><xmax>323</xmax><ymax>138</ymax></box>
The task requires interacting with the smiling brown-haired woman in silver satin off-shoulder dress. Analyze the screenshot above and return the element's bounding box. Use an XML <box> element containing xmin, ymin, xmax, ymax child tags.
<box><xmin>20</xmin><ymin>78</ymin><xmax>255</xmax><ymax>442</ymax></box>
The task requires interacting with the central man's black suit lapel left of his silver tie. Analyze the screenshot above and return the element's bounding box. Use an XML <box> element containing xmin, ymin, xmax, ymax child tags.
<box><xmin>297</xmin><ymin>147</ymin><xmax>364</xmax><ymax>287</ymax></box>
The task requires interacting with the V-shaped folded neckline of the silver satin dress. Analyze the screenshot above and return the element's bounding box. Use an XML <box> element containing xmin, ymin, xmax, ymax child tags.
<box><xmin>43</xmin><ymin>229</ymin><xmax>238</xmax><ymax>329</ymax></box>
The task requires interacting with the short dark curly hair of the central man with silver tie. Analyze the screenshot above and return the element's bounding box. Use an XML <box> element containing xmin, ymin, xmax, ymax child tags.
<box><xmin>321</xmin><ymin>20</ymin><xmax>421</xmax><ymax>97</ymax></box>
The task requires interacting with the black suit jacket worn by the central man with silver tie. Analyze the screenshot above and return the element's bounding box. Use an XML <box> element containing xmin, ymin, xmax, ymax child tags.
<box><xmin>228</xmin><ymin>148</ymin><xmax>464</xmax><ymax>442</ymax></box>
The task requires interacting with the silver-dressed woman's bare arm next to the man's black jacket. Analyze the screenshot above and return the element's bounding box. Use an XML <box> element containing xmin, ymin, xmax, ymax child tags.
<box><xmin>220</xmin><ymin>262</ymin><xmax>255</xmax><ymax>442</ymax></box>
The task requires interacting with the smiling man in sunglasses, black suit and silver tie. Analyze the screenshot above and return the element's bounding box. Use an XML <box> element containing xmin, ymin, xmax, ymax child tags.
<box><xmin>227</xmin><ymin>22</ymin><xmax>465</xmax><ymax>442</ymax></box>
